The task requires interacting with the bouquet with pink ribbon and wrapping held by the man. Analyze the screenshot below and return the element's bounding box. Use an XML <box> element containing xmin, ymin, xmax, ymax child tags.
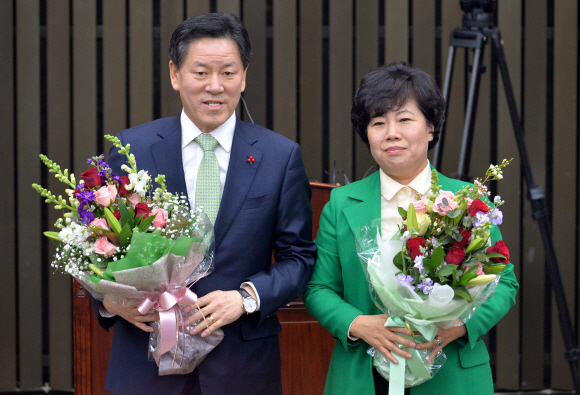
<box><xmin>32</xmin><ymin>135</ymin><xmax>223</xmax><ymax>375</ymax></box>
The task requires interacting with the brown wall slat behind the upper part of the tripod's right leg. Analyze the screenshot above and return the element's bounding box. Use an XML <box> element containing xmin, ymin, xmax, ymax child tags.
<box><xmin>496</xmin><ymin>2</ymin><xmax>528</xmax><ymax>390</ymax></box>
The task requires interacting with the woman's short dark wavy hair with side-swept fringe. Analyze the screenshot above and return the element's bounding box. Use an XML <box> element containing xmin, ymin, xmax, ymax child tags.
<box><xmin>350</xmin><ymin>62</ymin><xmax>445</xmax><ymax>149</ymax></box>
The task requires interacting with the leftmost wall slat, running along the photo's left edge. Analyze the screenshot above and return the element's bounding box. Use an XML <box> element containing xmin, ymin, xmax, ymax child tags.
<box><xmin>0</xmin><ymin>1</ymin><xmax>17</xmax><ymax>389</ymax></box>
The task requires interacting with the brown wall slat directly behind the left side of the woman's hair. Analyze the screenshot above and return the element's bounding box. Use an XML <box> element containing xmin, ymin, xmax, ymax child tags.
<box><xmin>349</xmin><ymin>0</ymin><xmax>382</xmax><ymax>180</ymax></box>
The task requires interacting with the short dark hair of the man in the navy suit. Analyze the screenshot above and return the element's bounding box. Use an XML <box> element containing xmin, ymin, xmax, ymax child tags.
<box><xmin>169</xmin><ymin>13</ymin><xmax>252</xmax><ymax>70</ymax></box>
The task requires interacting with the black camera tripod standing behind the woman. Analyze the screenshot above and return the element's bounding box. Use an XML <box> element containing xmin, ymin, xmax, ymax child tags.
<box><xmin>433</xmin><ymin>20</ymin><xmax>580</xmax><ymax>394</ymax></box>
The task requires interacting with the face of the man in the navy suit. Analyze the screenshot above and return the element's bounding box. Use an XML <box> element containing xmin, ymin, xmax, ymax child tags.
<box><xmin>169</xmin><ymin>38</ymin><xmax>247</xmax><ymax>133</ymax></box>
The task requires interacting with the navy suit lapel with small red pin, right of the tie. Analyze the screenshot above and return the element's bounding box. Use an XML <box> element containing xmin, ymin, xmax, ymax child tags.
<box><xmin>215</xmin><ymin>118</ymin><xmax>262</xmax><ymax>248</ymax></box>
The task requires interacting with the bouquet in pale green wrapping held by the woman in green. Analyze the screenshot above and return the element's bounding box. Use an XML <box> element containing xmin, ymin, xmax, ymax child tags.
<box><xmin>355</xmin><ymin>160</ymin><xmax>510</xmax><ymax>394</ymax></box>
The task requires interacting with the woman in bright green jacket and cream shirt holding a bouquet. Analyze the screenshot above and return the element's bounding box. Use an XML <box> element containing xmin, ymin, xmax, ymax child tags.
<box><xmin>303</xmin><ymin>63</ymin><xmax>518</xmax><ymax>395</ymax></box>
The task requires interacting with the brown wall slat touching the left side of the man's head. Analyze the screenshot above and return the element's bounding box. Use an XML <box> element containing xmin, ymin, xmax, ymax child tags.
<box><xmin>159</xmin><ymin>0</ymin><xmax>184</xmax><ymax>117</ymax></box>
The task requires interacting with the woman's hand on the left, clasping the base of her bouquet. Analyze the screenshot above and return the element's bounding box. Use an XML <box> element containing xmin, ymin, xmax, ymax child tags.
<box><xmin>350</xmin><ymin>314</ymin><xmax>432</xmax><ymax>363</ymax></box>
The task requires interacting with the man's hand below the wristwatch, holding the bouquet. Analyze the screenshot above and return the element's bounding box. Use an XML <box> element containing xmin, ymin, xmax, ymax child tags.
<box><xmin>184</xmin><ymin>291</ymin><xmax>244</xmax><ymax>337</ymax></box>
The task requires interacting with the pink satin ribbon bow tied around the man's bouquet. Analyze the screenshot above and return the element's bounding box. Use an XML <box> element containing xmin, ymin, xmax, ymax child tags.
<box><xmin>137</xmin><ymin>287</ymin><xmax>197</xmax><ymax>355</ymax></box>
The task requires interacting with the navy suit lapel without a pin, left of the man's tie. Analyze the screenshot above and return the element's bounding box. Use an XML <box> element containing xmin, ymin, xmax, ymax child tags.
<box><xmin>151</xmin><ymin>116</ymin><xmax>187</xmax><ymax>195</ymax></box>
